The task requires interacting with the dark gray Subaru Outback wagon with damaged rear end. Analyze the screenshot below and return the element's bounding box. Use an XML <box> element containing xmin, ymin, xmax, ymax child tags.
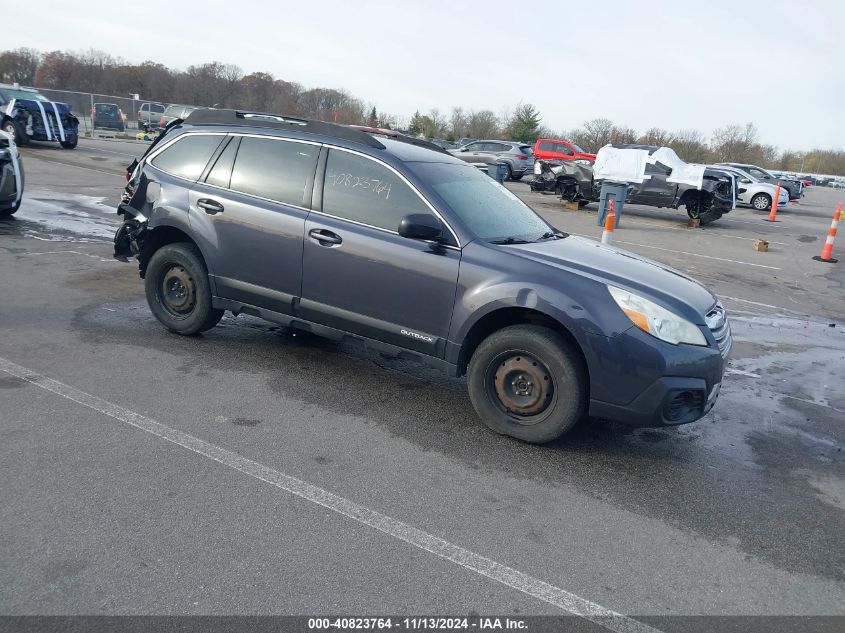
<box><xmin>115</xmin><ymin>110</ymin><xmax>731</xmax><ymax>442</ymax></box>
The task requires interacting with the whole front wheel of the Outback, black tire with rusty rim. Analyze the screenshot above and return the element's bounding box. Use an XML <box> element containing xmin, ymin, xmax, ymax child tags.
<box><xmin>467</xmin><ymin>325</ymin><xmax>588</xmax><ymax>444</ymax></box>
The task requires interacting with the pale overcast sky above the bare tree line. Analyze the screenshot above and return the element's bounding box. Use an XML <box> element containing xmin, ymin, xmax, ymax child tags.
<box><xmin>6</xmin><ymin>0</ymin><xmax>845</xmax><ymax>149</ymax></box>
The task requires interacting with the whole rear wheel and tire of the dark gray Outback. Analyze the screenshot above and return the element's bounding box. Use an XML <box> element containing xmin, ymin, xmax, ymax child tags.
<box><xmin>144</xmin><ymin>242</ymin><xmax>223</xmax><ymax>336</ymax></box>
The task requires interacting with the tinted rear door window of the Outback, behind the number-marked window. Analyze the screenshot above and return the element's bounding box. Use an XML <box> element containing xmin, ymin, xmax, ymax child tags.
<box><xmin>224</xmin><ymin>136</ymin><xmax>320</xmax><ymax>207</ymax></box>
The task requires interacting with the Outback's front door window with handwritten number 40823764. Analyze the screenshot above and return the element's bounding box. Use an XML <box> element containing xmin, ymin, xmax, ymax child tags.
<box><xmin>323</xmin><ymin>149</ymin><xmax>431</xmax><ymax>232</ymax></box>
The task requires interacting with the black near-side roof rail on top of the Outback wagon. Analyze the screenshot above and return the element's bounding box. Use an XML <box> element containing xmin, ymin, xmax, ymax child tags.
<box><xmin>185</xmin><ymin>108</ymin><xmax>385</xmax><ymax>149</ymax></box>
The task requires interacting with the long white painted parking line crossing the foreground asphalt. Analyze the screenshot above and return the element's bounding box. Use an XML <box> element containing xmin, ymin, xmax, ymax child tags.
<box><xmin>0</xmin><ymin>358</ymin><xmax>660</xmax><ymax>633</ymax></box>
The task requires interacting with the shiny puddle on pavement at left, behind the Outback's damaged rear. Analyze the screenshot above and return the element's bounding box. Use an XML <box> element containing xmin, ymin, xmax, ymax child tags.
<box><xmin>0</xmin><ymin>190</ymin><xmax>119</xmax><ymax>242</ymax></box>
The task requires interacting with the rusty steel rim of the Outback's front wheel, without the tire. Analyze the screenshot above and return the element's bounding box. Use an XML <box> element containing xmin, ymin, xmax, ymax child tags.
<box><xmin>485</xmin><ymin>350</ymin><xmax>557</xmax><ymax>426</ymax></box>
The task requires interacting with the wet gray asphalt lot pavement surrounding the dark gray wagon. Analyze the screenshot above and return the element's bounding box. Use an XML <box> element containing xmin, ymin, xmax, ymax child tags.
<box><xmin>0</xmin><ymin>141</ymin><xmax>845</xmax><ymax>628</ymax></box>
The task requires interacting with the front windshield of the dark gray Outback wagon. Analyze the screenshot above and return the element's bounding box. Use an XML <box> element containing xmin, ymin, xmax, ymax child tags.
<box><xmin>407</xmin><ymin>163</ymin><xmax>557</xmax><ymax>243</ymax></box>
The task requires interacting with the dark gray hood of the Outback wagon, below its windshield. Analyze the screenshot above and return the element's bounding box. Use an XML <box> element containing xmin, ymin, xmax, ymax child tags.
<box><xmin>502</xmin><ymin>235</ymin><xmax>716</xmax><ymax>325</ymax></box>
